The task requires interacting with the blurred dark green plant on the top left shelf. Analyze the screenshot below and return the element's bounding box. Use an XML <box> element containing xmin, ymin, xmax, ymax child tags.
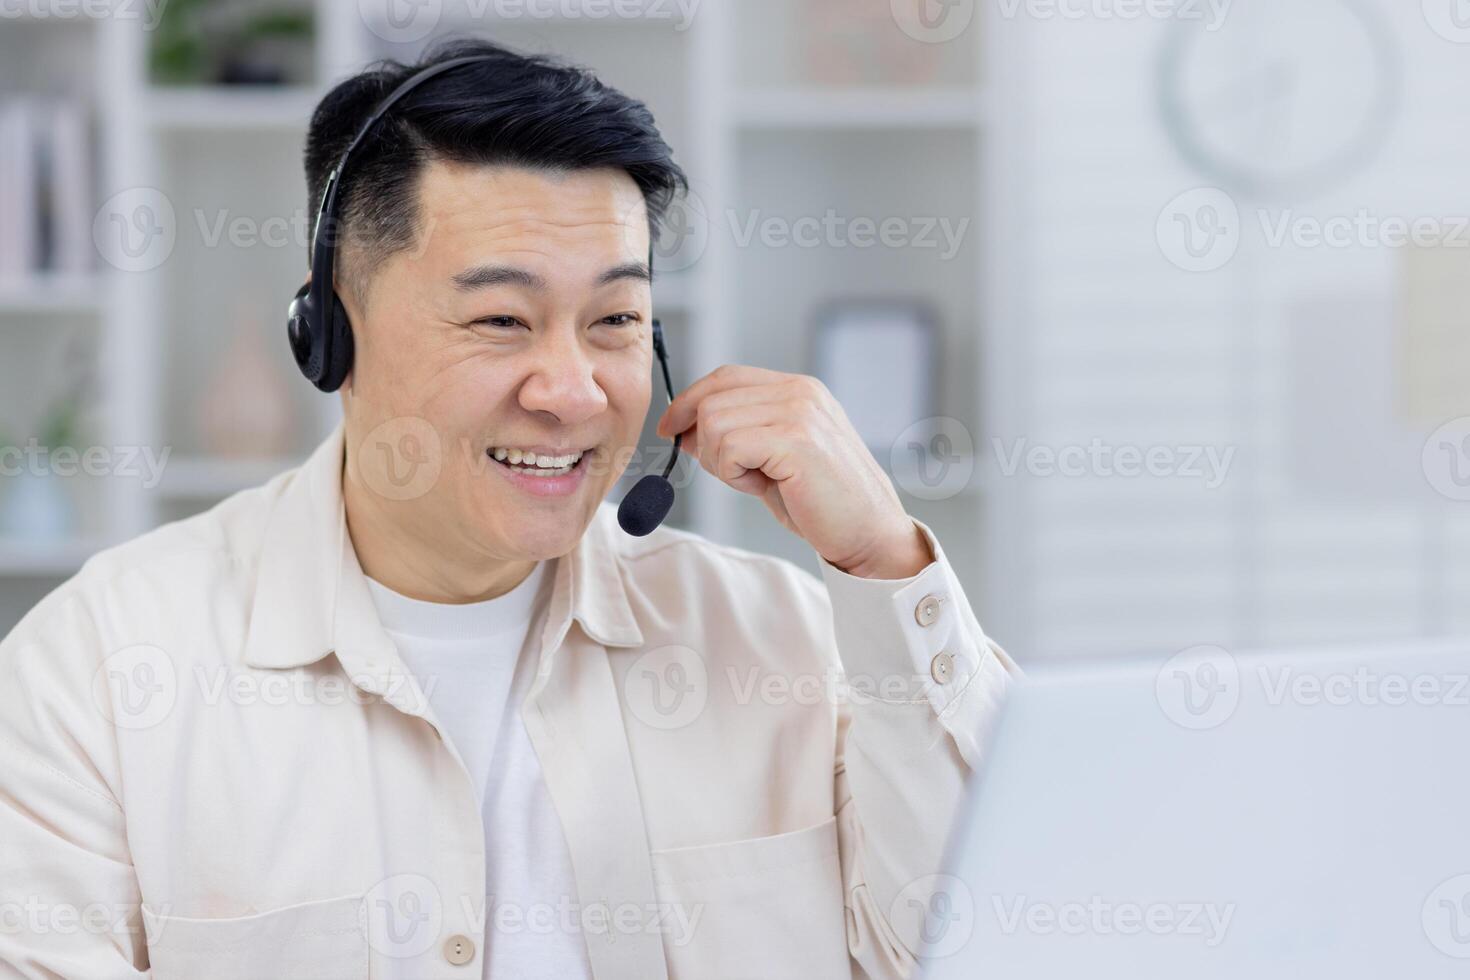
<box><xmin>150</xmin><ymin>0</ymin><xmax>315</xmax><ymax>85</ymax></box>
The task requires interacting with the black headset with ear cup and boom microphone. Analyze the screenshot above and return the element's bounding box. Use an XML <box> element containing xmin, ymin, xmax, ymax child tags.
<box><xmin>285</xmin><ymin>54</ymin><xmax>681</xmax><ymax>536</ymax></box>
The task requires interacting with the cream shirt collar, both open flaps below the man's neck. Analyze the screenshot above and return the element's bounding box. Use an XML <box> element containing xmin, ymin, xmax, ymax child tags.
<box><xmin>244</xmin><ymin>423</ymin><xmax>642</xmax><ymax>673</ymax></box>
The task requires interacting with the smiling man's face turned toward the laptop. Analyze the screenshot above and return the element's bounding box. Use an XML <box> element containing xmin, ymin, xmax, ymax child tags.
<box><xmin>343</xmin><ymin>162</ymin><xmax>651</xmax><ymax>561</ymax></box>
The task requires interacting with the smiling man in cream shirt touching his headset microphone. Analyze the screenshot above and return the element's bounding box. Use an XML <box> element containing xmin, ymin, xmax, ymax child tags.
<box><xmin>0</xmin><ymin>43</ymin><xmax>1013</xmax><ymax>980</ymax></box>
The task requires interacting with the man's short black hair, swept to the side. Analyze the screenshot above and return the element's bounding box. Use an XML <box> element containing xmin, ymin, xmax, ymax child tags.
<box><xmin>306</xmin><ymin>38</ymin><xmax>688</xmax><ymax>297</ymax></box>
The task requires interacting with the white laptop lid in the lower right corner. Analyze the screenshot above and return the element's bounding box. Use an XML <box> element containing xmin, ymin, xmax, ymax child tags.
<box><xmin>922</xmin><ymin>641</ymin><xmax>1470</xmax><ymax>980</ymax></box>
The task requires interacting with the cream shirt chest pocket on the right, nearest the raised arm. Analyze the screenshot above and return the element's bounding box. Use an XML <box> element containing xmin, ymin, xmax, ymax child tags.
<box><xmin>653</xmin><ymin>817</ymin><xmax>851</xmax><ymax>980</ymax></box>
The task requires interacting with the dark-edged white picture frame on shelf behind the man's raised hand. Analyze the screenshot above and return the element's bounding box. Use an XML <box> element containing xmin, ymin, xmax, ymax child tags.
<box><xmin>813</xmin><ymin>300</ymin><xmax>936</xmax><ymax>460</ymax></box>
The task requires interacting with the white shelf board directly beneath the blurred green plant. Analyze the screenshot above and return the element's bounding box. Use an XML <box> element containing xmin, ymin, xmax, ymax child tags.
<box><xmin>144</xmin><ymin>85</ymin><xmax>320</xmax><ymax>134</ymax></box>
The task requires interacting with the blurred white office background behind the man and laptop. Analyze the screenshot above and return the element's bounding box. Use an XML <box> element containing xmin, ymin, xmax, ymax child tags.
<box><xmin>0</xmin><ymin>0</ymin><xmax>1470</xmax><ymax>661</ymax></box>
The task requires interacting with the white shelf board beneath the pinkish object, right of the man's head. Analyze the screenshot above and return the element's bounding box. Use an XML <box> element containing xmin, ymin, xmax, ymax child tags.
<box><xmin>736</xmin><ymin>88</ymin><xmax>985</xmax><ymax>129</ymax></box>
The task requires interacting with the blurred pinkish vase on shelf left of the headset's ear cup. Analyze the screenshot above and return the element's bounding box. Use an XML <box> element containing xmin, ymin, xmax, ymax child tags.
<box><xmin>196</xmin><ymin>301</ymin><xmax>294</xmax><ymax>458</ymax></box>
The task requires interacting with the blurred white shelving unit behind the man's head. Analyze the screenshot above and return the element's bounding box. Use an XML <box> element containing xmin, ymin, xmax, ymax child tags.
<box><xmin>0</xmin><ymin>0</ymin><xmax>994</xmax><ymax>624</ymax></box>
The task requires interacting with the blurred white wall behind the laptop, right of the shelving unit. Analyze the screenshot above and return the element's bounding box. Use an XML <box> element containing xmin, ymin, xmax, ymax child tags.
<box><xmin>986</xmin><ymin>0</ymin><xmax>1470</xmax><ymax>655</ymax></box>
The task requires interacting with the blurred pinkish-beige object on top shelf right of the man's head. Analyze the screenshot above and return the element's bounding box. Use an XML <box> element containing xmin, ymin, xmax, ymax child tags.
<box><xmin>798</xmin><ymin>0</ymin><xmax>939</xmax><ymax>85</ymax></box>
